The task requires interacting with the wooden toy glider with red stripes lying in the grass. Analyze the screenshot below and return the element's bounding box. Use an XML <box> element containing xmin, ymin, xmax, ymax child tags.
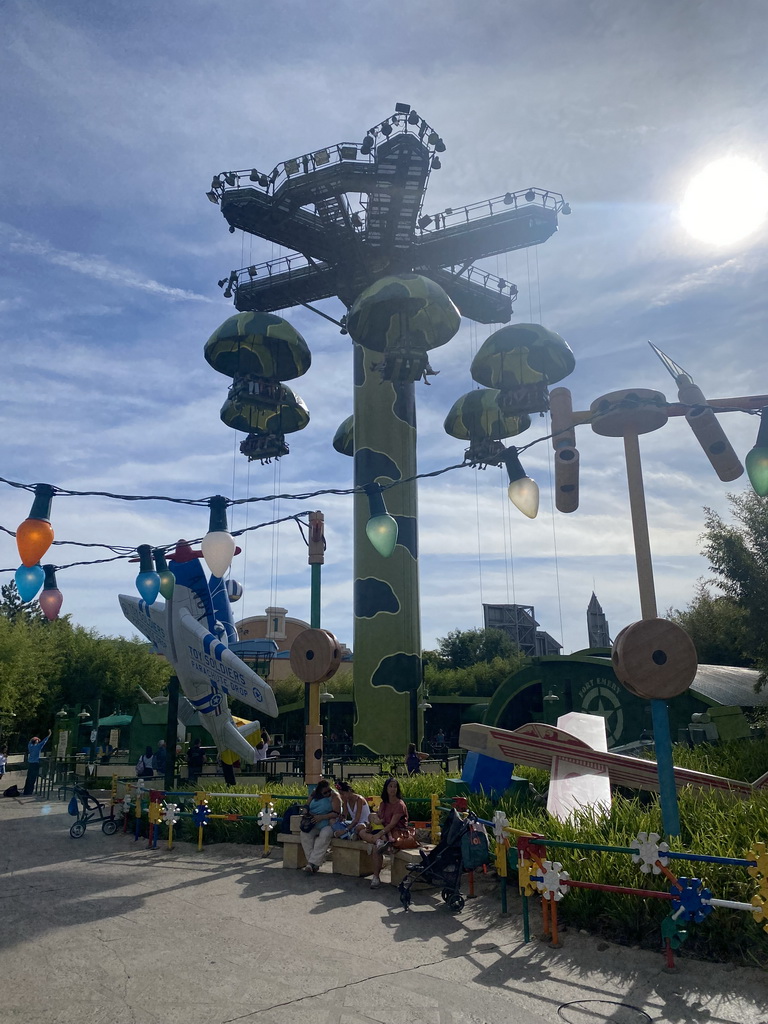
<box><xmin>459</xmin><ymin>722</ymin><xmax>768</xmax><ymax>797</ymax></box>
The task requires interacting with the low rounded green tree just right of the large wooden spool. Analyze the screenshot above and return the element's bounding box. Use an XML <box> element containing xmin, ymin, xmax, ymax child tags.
<box><xmin>667</xmin><ymin>581</ymin><xmax>755</xmax><ymax>668</ymax></box>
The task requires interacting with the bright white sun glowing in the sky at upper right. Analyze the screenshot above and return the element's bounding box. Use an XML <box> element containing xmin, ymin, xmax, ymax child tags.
<box><xmin>680</xmin><ymin>157</ymin><xmax>768</xmax><ymax>246</ymax></box>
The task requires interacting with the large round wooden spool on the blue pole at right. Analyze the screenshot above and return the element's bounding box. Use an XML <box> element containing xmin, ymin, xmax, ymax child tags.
<box><xmin>611</xmin><ymin>618</ymin><xmax>698</xmax><ymax>700</ymax></box>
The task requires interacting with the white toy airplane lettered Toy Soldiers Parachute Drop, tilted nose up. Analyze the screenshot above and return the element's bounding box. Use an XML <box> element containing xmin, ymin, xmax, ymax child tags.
<box><xmin>119</xmin><ymin>541</ymin><xmax>278</xmax><ymax>764</ymax></box>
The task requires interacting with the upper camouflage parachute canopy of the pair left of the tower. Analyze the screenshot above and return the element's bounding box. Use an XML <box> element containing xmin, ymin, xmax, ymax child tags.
<box><xmin>205</xmin><ymin>312</ymin><xmax>312</xmax><ymax>381</ymax></box>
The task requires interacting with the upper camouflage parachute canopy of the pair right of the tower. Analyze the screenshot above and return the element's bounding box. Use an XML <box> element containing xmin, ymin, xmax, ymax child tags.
<box><xmin>470</xmin><ymin>324</ymin><xmax>575</xmax><ymax>390</ymax></box>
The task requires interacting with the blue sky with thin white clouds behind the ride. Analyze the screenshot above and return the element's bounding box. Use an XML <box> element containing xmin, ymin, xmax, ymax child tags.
<box><xmin>0</xmin><ymin>0</ymin><xmax>768</xmax><ymax>653</ymax></box>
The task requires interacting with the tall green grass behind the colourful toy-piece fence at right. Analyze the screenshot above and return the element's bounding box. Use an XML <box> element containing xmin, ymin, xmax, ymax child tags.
<box><xmin>469</xmin><ymin>740</ymin><xmax>768</xmax><ymax>968</ymax></box>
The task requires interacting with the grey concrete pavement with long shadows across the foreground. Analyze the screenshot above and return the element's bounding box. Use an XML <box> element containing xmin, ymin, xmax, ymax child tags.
<box><xmin>0</xmin><ymin>798</ymin><xmax>768</xmax><ymax>1024</ymax></box>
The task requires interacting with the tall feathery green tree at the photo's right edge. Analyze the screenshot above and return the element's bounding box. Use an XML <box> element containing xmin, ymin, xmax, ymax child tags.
<box><xmin>702</xmin><ymin>490</ymin><xmax>768</xmax><ymax>685</ymax></box>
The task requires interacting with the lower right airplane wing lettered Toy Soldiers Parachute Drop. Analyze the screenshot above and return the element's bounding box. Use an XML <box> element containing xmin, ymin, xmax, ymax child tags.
<box><xmin>174</xmin><ymin>608</ymin><xmax>278</xmax><ymax>728</ymax></box>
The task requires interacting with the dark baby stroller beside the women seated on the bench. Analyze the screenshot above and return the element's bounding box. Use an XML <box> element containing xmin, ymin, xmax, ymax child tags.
<box><xmin>399</xmin><ymin>810</ymin><xmax>490</xmax><ymax>911</ymax></box>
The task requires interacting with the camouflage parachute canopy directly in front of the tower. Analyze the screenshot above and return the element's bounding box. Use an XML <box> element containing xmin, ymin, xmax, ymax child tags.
<box><xmin>347</xmin><ymin>273</ymin><xmax>461</xmax><ymax>352</ymax></box>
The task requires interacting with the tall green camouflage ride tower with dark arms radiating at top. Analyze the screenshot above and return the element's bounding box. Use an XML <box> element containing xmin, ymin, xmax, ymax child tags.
<box><xmin>207</xmin><ymin>103</ymin><xmax>570</xmax><ymax>754</ymax></box>
